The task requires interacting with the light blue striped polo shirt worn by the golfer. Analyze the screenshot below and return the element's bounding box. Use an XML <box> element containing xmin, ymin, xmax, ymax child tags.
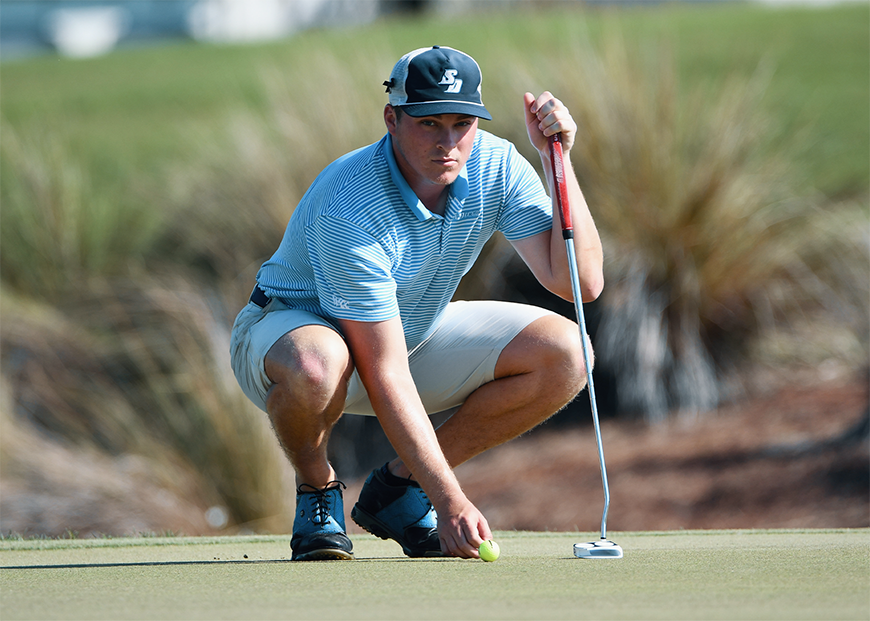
<box><xmin>257</xmin><ymin>130</ymin><xmax>552</xmax><ymax>351</ymax></box>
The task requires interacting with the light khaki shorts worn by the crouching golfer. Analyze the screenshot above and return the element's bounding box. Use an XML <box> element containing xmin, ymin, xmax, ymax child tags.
<box><xmin>230</xmin><ymin>299</ymin><xmax>553</xmax><ymax>416</ymax></box>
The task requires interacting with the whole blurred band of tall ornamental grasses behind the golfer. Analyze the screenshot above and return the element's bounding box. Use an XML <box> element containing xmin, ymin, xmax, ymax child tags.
<box><xmin>0</xmin><ymin>10</ymin><xmax>870</xmax><ymax>534</ymax></box>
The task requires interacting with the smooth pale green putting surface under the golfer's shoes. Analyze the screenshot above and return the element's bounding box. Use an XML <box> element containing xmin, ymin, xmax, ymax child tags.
<box><xmin>0</xmin><ymin>529</ymin><xmax>870</xmax><ymax>620</ymax></box>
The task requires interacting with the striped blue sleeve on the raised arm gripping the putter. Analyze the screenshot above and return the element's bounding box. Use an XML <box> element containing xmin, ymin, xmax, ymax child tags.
<box><xmin>498</xmin><ymin>145</ymin><xmax>553</xmax><ymax>241</ymax></box>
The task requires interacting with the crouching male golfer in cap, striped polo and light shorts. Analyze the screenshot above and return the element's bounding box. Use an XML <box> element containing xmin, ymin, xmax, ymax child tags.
<box><xmin>231</xmin><ymin>46</ymin><xmax>603</xmax><ymax>560</ymax></box>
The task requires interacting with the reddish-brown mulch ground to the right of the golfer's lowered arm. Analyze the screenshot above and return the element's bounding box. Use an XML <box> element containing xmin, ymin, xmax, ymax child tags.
<box><xmin>346</xmin><ymin>381</ymin><xmax>870</xmax><ymax>531</ymax></box>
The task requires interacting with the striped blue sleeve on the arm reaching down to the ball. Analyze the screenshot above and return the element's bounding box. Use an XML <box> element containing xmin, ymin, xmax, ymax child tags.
<box><xmin>307</xmin><ymin>216</ymin><xmax>399</xmax><ymax>321</ymax></box>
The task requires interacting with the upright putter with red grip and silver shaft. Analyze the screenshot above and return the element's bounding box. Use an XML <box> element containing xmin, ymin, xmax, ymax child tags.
<box><xmin>549</xmin><ymin>134</ymin><xmax>622</xmax><ymax>558</ymax></box>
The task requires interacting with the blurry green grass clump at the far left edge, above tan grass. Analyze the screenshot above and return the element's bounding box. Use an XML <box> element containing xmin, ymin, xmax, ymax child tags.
<box><xmin>0</xmin><ymin>117</ymin><xmax>162</xmax><ymax>299</ymax></box>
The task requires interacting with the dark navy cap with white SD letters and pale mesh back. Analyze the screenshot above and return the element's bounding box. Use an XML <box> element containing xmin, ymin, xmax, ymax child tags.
<box><xmin>384</xmin><ymin>45</ymin><xmax>492</xmax><ymax>121</ymax></box>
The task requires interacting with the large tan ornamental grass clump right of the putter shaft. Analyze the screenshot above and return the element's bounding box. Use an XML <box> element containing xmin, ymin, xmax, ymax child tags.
<box><xmin>516</xmin><ymin>33</ymin><xmax>867</xmax><ymax>421</ymax></box>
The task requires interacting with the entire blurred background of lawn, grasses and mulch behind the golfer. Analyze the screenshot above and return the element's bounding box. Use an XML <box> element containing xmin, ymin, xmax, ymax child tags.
<box><xmin>0</xmin><ymin>0</ymin><xmax>870</xmax><ymax>537</ymax></box>
